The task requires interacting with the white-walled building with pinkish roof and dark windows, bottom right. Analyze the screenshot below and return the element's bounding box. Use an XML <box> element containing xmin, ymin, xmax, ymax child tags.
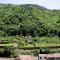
<box><xmin>38</xmin><ymin>54</ymin><xmax>60</xmax><ymax>60</ymax></box>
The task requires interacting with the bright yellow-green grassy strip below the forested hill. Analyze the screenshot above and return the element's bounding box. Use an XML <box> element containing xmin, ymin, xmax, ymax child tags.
<box><xmin>0</xmin><ymin>36</ymin><xmax>60</xmax><ymax>48</ymax></box>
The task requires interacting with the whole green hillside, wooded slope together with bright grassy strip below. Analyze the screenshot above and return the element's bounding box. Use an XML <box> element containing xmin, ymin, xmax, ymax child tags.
<box><xmin>0</xmin><ymin>4</ymin><xmax>60</xmax><ymax>56</ymax></box>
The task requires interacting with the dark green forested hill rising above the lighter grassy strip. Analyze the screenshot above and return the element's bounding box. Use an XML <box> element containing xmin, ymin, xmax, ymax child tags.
<box><xmin>0</xmin><ymin>4</ymin><xmax>60</xmax><ymax>36</ymax></box>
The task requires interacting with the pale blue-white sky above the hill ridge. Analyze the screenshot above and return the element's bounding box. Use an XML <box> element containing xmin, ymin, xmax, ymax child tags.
<box><xmin>0</xmin><ymin>0</ymin><xmax>60</xmax><ymax>9</ymax></box>
